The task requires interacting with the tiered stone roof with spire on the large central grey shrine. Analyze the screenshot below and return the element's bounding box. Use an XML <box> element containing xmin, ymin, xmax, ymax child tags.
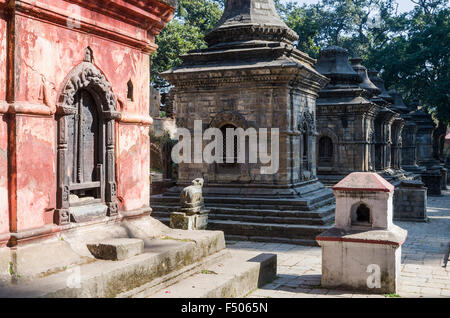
<box><xmin>163</xmin><ymin>0</ymin><xmax>327</xmax><ymax>90</ymax></box>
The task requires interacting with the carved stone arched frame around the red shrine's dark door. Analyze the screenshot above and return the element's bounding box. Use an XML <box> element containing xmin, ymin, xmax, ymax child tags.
<box><xmin>54</xmin><ymin>48</ymin><xmax>120</xmax><ymax>225</ymax></box>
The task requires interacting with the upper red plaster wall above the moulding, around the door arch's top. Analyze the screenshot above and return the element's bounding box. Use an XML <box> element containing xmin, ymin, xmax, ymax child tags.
<box><xmin>16</xmin><ymin>17</ymin><xmax>149</xmax><ymax>114</ymax></box>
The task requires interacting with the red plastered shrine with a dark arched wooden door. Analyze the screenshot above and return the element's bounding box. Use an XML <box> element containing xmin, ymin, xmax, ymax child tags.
<box><xmin>0</xmin><ymin>0</ymin><xmax>176</xmax><ymax>282</ymax></box>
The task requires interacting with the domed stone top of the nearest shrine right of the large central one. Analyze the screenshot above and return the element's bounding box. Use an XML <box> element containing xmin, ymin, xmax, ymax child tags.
<box><xmin>316</xmin><ymin>46</ymin><xmax>362</xmax><ymax>85</ymax></box>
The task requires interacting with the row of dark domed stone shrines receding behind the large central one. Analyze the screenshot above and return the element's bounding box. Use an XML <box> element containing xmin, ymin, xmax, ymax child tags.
<box><xmin>151</xmin><ymin>47</ymin><xmax>447</xmax><ymax>195</ymax></box>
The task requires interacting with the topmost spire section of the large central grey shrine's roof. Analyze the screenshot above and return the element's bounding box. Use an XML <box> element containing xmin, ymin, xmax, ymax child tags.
<box><xmin>205</xmin><ymin>0</ymin><xmax>298</xmax><ymax>47</ymax></box>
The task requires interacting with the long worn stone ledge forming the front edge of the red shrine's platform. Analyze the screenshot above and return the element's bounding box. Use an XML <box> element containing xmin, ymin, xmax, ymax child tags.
<box><xmin>0</xmin><ymin>220</ymin><xmax>226</xmax><ymax>298</ymax></box>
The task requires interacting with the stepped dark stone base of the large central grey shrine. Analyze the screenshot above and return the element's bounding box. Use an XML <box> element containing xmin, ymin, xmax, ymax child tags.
<box><xmin>150</xmin><ymin>179</ymin><xmax>334</xmax><ymax>245</ymax></box>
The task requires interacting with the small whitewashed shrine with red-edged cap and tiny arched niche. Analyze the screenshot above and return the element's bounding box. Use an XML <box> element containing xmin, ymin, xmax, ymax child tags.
<box><xmin>316</xmin><ymin>172</ymin><xmax>407</xmax><ymax>294</ymax></box>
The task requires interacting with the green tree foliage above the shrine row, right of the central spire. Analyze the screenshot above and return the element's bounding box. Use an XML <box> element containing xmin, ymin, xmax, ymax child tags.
<box><xmin>276</xmin><ymin>0</ymin><xmax>450</xmax><ymax>123</ymax></box>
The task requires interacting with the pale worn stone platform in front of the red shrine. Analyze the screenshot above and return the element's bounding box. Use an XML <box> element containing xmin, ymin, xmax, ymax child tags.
<box><xmin>0</xmin><ymin>216</ymin><xmax>273</xmax><ymax>297</ymax></box>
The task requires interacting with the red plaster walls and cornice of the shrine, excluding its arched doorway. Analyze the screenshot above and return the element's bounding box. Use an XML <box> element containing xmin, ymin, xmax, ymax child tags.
<box><xmin>0</xmin><ymin>0</ymin><xmax>173</xmax><ymax>234</ymax></box>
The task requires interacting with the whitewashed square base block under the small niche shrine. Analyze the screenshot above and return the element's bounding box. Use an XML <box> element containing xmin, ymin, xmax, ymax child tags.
<box><xmin>317</xmin><ymin>226</ymin><xmax>407</xmax><ymax>294</ymax></box>
